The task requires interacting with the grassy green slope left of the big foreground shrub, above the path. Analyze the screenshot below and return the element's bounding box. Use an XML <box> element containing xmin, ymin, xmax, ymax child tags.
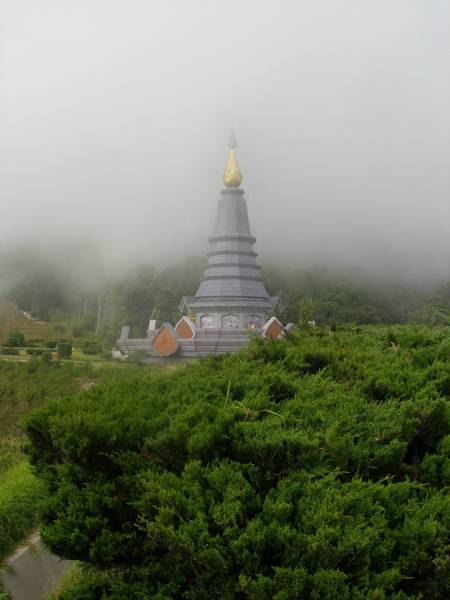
<box><xmin>0</xmin><ymin>357</ymin><xmax>153</xmax><ymax>562</ymax></box>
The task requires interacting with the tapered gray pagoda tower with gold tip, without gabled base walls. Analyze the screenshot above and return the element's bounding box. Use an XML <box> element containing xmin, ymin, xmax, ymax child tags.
<box><xmin>179</xmin><ymin>133</ymin><xmax>281</xmax><ymax>330</ymax></box>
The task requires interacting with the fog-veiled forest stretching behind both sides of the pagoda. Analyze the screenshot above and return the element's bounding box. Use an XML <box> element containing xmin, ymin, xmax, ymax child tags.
<box><xmin>0</xmin><ymin>244</ymin><xmax>450</xmax><ymax>348</ymax></box>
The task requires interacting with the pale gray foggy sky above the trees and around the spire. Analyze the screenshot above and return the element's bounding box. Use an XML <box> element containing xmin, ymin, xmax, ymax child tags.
<box><xmin>0</xmin><ymin>0</ymin><xmax>450</xmax><ymax>277</ymax></box>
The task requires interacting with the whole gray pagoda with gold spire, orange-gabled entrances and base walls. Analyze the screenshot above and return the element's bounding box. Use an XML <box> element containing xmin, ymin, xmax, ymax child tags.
<box><xmin>113</xmin><ymin>135</ymin><xmax>284</xmax><ymax>362</ymax></box>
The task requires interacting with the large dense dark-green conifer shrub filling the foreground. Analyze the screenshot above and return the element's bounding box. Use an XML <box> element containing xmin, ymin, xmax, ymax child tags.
<box><xmin>26</xmin><ymin>327</ymin><xmax>450</xmax><ymax>600</ymax></box>
